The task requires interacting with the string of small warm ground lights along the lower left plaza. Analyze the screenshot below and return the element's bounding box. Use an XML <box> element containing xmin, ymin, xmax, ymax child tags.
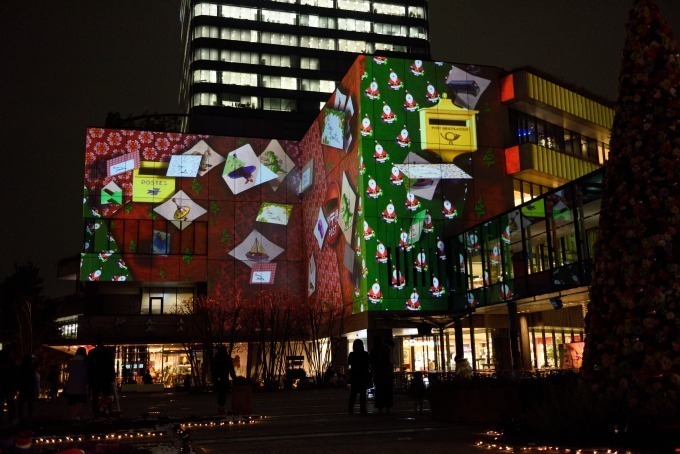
<box><xmin>33</xmin><ymin>415</ymin><xmax>267</xmax><ymax>446</ymax></box>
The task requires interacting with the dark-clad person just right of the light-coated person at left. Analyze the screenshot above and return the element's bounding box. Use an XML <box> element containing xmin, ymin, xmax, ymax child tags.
<box><xmin>87</xmin><ymin>339</ymin><xmax>116</xmax><ymax>418</ymax></box>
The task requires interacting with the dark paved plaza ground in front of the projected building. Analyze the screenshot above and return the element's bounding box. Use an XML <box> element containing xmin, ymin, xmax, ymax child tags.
<box><xmin>2</xmin><ymin>389</ymin><xmax>489</xmax><ymax>453</ymax></box>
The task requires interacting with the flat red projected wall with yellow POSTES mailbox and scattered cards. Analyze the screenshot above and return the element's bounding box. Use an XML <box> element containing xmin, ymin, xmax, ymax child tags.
<box><xmin>81</xmin><ymin>128</ymin><xmax>303</xmax><ymax>297</ymax></box>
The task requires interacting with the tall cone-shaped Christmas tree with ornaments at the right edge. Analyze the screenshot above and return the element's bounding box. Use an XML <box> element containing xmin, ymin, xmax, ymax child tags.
<box><xmin>583</xmin><ymin>0</ymin><xmax>680</xmax><ymax>417</ymax></box>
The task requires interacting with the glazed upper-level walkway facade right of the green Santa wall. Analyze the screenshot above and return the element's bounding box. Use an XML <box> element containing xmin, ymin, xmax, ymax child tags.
<box><xmin>450</xmin><ymin>170</ymin><xmax>602</xmax><ymax>310</ymax></box>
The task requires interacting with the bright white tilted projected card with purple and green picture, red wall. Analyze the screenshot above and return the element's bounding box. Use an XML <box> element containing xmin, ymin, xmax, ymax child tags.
<box><xmin>222</xmin><ymin>144</ymin><xmax>276</xmax><ymax>194</ymax></box>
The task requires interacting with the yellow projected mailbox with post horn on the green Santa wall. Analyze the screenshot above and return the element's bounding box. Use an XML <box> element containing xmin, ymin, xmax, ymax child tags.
<box><xmin>420</xmin><ymin>94</ymin><xmax>478</xmax><ymax>162</ymax></box>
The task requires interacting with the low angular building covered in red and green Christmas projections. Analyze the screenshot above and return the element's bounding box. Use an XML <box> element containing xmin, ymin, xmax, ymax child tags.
<box><xmin>74</xmin><ymin>55</ymin><xmax>613</xmax><ymax>384</ymax></box>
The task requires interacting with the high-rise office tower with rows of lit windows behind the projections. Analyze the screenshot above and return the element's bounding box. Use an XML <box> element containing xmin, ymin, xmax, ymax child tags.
<box><xmin>180</xmin><ymin>0</ymin><xmax>429</xmax><ymax>139</ymax></box>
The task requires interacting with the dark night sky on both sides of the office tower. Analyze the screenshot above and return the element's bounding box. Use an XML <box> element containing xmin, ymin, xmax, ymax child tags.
<box><xmin>0</xmin><ymin>0</ymin><xmax>680</xmax><ymax>296</ymax></box>
